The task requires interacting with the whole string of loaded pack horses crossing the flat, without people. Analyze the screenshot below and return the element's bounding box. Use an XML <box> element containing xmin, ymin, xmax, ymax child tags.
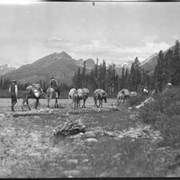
<box><xmin>19</xmin><ymin>84</ymin><xmax>152</xmax><ymax>110</ymax></box>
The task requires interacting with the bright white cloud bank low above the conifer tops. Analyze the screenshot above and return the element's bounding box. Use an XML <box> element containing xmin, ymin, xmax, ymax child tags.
<box><xmin>70</xmin><ymin>36</ymin><xmax>170</xmax><ymax>62</ymax></box>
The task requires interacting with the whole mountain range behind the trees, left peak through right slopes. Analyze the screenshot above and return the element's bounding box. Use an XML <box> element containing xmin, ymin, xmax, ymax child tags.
<box><xmin>0</xmin><ymin>46</ymin><xmax>174</xmax><ymax>85</ymax></box>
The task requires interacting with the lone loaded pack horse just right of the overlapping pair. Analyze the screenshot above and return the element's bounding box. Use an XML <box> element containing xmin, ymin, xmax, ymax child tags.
<box><xmin>94</xmin><ymin>89</ymin><xmax>107</xmax><ymax>107</ymax></box>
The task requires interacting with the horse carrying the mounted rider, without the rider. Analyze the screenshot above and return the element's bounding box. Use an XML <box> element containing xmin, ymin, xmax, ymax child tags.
<box><xmin>46</xmin><ymin>86</ymin><xmax>62</xmax><ymax>108</ymax></box>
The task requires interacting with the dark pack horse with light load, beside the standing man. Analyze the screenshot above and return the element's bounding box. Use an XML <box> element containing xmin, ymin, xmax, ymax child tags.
<box><xmin>21</xmin><ymin>84</ymin><xmax>44</xmax><ymax>110</ymax></box>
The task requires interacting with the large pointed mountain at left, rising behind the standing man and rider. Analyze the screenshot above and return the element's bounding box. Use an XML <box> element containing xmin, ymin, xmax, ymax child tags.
<box><xmin>1</xmin><ymin>51</ymin><xmax>95</xmax><ymax>85</ymax></box>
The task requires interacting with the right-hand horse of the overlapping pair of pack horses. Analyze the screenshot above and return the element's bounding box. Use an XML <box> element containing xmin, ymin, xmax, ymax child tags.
<box><xmin>77</xmin><ymin>88</ymin><xmax>90</xmax><ymax>108</ymax></box>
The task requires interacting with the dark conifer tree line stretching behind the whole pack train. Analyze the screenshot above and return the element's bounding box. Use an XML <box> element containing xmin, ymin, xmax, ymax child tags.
<box><xmin>0</xmin><ymin>40</ymin><xmax>180</xmax><ymax>94</ymax></box>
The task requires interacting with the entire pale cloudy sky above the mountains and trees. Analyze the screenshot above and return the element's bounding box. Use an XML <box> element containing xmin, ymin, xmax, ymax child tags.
<box><xmin>0</xmin><ymin>1</ymin><xmax>180</xmax><ymax>67</ymax></box>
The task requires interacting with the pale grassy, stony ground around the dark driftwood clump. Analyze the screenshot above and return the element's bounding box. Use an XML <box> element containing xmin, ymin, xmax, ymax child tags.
<box><xmin>0</xmin><ymin>95</ymin><xmax>180</xmax><ymax>178</ymax></box>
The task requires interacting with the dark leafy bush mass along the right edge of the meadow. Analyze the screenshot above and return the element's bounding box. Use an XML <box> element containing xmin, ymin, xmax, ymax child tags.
<box><xmin>139</xmin><ymin>87</ymin><xmax>180</xmax><ymax>146</ymax></box>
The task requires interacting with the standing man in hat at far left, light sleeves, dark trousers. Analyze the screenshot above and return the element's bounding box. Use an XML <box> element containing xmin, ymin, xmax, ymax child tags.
<box><xmin>9</xmin><ymin>80</ymin><xmax>18</xmax><ymax>111</ymax></box>
